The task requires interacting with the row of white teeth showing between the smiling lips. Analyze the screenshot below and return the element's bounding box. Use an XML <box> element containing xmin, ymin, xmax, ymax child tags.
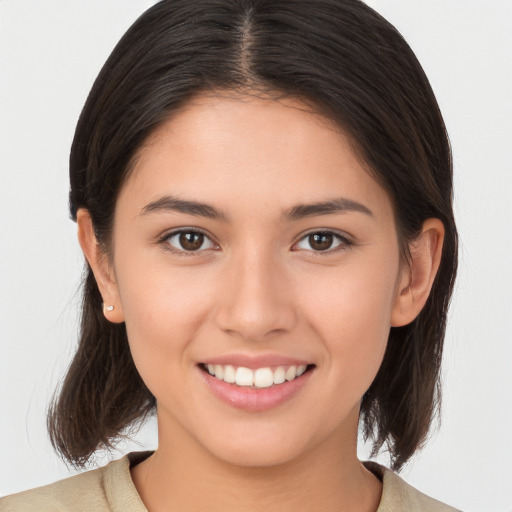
<box><xmin>199</xmin><ymin>363</ymin><xmax>315</xmax><ymax>389</ymax></box>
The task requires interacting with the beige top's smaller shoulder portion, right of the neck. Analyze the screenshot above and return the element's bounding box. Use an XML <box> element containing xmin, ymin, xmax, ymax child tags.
<box><xmin>365</xmin><ymin>462</ymin><xmax>458</xmax><ymax>512</ymax></box>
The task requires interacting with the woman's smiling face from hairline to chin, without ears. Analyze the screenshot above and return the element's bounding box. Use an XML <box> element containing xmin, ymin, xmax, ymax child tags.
<box><xmin>107</xmin><ymin>92</ymin><xmax>401</xmax><ymax>466</ymax></box>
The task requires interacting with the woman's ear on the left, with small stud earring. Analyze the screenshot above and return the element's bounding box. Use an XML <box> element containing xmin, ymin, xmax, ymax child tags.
<box><xmin>76</xmin><ymin>208</ymin><xmax>124</xmax><ymax>323</ymax></box>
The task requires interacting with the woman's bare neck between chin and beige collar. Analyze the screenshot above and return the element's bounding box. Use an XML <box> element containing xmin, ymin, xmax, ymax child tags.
<box><xmin>132</xmin><ymin>412</ymin><xmax>381</xmax><ymax>512</ymax></box>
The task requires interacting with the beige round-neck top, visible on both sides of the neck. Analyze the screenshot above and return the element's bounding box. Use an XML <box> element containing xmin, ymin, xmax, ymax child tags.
<box><xmin>0</xmin><ymin>452</ymin><xmax>457</xmax><ymax>512</ymax></box>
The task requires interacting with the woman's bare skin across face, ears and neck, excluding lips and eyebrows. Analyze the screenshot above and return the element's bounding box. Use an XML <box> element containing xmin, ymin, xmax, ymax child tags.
<box><xmin>78</xmin><ymin>95</ymin><xmax>444</xmax><ymax>512</ymax></box>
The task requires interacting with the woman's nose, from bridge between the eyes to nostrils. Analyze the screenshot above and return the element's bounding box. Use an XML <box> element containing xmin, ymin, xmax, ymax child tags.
<box><xmin>216</xmin><ymin>248</ymin><xmax>297</xmax><ymax>341</ymax></box>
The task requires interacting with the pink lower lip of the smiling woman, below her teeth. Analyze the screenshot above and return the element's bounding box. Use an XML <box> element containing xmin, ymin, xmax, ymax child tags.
<box><xmin>198</xmin><ymin>368</ymin><xmax>313</xmax><ymax>412</ymax></box>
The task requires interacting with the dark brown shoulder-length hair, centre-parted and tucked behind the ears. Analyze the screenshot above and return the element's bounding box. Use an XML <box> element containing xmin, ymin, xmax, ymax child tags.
<box><xmin>48</xmin><ymin>0</ymin><xmax>457</xmax><ymax>469</ymax></box>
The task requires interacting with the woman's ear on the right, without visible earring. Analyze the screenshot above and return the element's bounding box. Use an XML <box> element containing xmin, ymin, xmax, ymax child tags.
<box><xmin>391</xmin><ymin>219</ymin><xmax>444</xmax><ymax>327</ymax></box>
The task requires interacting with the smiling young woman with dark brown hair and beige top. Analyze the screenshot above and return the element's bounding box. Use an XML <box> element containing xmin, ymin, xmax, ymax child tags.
<box><xmin>0</xmin><ymin>0</ymin><xmax>457</xmax><ymax>512</ymax></box>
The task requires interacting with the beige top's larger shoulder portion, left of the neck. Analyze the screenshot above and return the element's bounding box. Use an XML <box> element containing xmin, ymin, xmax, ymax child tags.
<box><xmin>0</xmin><ymin>454</ymin><xmax>146</xmax><ymax>512</ymax></box>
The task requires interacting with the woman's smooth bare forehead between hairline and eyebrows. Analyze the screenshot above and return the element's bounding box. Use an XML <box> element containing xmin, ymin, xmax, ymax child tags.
<box><xmin>120</xmin><ymin>95</ymin><xmax>390</xmax><ymax>224</ymax></box>
